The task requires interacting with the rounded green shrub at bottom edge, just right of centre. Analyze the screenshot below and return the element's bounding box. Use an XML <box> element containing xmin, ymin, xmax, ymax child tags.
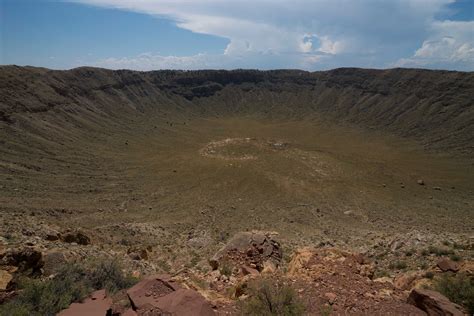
<box><xmin>242</xmin><ymin>279</ymin><xmax>305</xmax><ymax>316</ymax></box>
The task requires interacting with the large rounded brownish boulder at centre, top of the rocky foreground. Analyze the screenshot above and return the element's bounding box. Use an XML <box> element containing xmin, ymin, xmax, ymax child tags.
<box><xmin>209</xmin><ymin>231</ymin><xmax>282</xmax><ymax>271</ymax></box>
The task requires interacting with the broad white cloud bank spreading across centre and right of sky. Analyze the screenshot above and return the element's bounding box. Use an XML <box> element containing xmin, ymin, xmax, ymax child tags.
<box><xmin>68</xmin><ymin>0</ymin><xmax>474</xmax><ymax>70</ymax></box>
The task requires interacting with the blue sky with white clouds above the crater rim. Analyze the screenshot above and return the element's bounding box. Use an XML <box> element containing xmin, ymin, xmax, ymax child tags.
<box><xmin>0</xmin><ymin>0</ymin><xmax>474</xmax><ymax>71</ymax></box>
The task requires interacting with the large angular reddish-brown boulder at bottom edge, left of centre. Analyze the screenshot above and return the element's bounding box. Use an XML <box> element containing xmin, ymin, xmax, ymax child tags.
<box><xmin>127</xmin><ymin>275</ymin><xmax>214</xmax><ymax>316</ymax></box>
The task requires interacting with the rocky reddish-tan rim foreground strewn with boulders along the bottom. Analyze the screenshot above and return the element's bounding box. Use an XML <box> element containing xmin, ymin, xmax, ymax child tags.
<box><xmin>0</xmin><ymin>231</ymin><xmax>474</xmax><ymax>316</ymax></box>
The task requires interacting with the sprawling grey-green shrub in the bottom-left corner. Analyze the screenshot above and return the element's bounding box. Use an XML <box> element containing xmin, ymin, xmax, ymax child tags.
<box><xmin>0</xmin><ymin>261</ymin><xmax>135</xmax><ymax>316</ymax></box>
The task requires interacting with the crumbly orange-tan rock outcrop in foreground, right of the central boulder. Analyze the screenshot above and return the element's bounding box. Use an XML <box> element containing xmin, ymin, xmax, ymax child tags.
<box><xmin>287</xmin><ymin>248</ymin><xmax>424</xmax><ymax>315</ymax></box>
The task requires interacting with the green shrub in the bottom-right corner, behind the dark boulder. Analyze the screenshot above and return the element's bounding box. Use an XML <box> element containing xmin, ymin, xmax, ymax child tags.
<box><xmin>434</xmin><ymin>273</ymin><xmax>474</xmax><ymax>315</ymax></box>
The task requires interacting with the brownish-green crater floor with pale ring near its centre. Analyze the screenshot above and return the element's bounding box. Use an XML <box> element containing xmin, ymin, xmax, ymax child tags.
<box><xmin>0</xmin><ymin>116</ymin><xmax>474</xmax><ymax>266</ymax></box>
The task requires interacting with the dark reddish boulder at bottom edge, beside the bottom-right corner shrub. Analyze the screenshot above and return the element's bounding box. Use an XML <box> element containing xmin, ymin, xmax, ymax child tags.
<box><xmin>408</xmin><ymin>289</ymin><xmax>464</xmax><ymax>316</ymax></box>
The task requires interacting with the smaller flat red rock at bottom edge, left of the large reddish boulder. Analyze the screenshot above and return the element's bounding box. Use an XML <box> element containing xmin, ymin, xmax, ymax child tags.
<box><xmin>58</xmin><ymin>290</ymin><xmax>112</xmax><ymax>316</ymax></box>
